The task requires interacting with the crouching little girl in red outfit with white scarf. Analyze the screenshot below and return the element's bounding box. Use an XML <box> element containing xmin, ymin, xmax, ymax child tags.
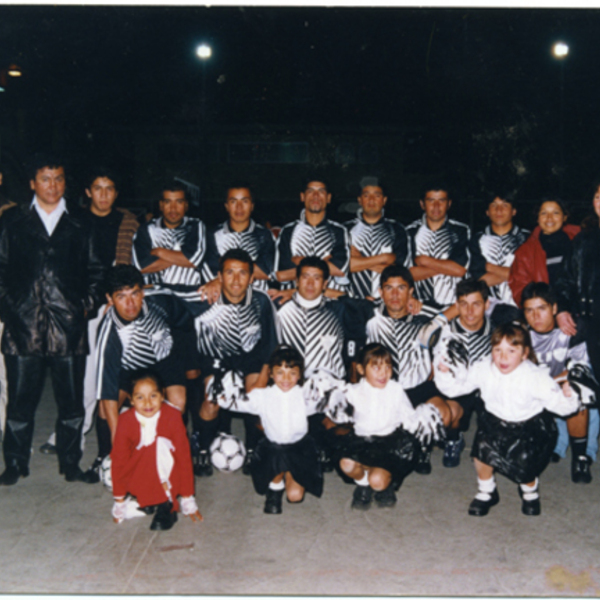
<box><xmin>111</xmin><ymin>371</ymin><xmax>202</xmax><ymax>530</ymax></box>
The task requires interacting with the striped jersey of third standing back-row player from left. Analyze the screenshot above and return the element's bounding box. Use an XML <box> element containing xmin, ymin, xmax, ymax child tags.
<box><xmin>274</xmin><ymin>210</ymin><xmax>350</xmax><ymax>290</ymax></box>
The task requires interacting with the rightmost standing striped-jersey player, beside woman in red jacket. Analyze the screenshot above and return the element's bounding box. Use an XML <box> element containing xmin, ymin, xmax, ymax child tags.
<box><xmin>469</xmin><ymin>192</ymin><xmax>530</xmax><ymax>306</ymax></box>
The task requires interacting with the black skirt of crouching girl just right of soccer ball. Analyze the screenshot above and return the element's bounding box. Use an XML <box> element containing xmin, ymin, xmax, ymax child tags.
<box><xmin>250</xmin><ymin>434</ymin><xmax>323</xmax><ymax>498</ymax></box>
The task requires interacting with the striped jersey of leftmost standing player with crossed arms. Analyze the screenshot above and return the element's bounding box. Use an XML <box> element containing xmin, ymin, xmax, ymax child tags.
<box><xmin>133</xmin><ymin>217</ymin><xmax>206</xmax><ymax>293</ymax></box>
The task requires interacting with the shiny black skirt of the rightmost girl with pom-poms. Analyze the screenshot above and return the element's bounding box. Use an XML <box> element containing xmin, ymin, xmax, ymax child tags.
<box><xmin>471</xmin><ymin>410</ymin><xmax>558</xmax><ymax>483</ymax></box>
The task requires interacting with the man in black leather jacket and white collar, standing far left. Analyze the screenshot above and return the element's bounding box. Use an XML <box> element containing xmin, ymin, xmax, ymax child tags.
<box><xmin>0</xmin><ymin>156</ymin><xmax>103</xmax><ymax>485</ymax></box>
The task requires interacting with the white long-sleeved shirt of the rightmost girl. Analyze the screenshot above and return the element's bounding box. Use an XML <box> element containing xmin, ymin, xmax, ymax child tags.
<box><xmin>435</xmin><ymin>357</ymin><xmax>579</xmax><ymax>423</ymax></box>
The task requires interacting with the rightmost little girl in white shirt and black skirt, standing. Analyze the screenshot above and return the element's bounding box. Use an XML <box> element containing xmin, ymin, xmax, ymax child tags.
<box><xmin>435</xmin><ymin>322</ymin><xmax>580</xmax><ymax>517</ymax></box>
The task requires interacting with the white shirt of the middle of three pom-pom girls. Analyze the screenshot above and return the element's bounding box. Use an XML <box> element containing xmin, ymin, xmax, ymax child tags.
<box><xmin>348</xmin><ymin>379</ymin><xmax>415</xmax><ymax>437</ymax></box>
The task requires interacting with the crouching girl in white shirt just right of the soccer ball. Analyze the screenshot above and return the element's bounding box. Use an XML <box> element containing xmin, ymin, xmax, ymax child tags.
<box><xmin>212</xmin><ymin>346</ymin><xmax>323</xmax><ymax>514</ymax></box>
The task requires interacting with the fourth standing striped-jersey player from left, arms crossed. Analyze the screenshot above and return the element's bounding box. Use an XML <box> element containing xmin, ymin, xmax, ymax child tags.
<box><xmin>345</xmin><ymin>180</ymin><xmax>410</xmax><ymax>298</ymax></box>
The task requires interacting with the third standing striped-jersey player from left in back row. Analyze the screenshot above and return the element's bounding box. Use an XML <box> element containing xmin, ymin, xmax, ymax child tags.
<box><xmin>274</xmin><ymin>179</ymin><xmax>350</xmax><ymax>290</ymax></box>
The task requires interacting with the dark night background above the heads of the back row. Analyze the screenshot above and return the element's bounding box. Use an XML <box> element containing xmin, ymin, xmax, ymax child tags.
<box><xmin>0</xmin><ymin>6</ymin><xmax>600</xmax><ymax>230</ymax></box>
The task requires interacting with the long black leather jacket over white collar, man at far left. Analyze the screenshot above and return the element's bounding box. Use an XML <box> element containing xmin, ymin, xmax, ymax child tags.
<box><xmin>0</xmin><ymin>207</ymin><xmax>104</xmax><ymax>356</ymax></box>
